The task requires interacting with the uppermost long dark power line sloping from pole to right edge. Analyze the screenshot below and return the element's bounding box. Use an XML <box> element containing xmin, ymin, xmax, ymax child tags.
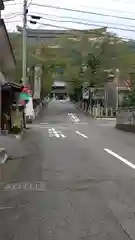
<box><xmin>32</xmin><ymin>3</ymin><xmax>135</xmax><ymax>21</ymax></box>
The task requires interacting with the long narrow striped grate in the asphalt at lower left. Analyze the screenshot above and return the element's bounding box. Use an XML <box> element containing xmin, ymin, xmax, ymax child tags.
<box><xmin>4</xmin><ymin>182</ymin><xmax>46</xmax><ymax>191</ymax></box>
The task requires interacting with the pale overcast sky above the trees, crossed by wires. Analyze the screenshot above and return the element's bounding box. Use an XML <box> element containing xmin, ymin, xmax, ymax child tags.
<box><xmin>2</xmin><ymin>0</ymin><xmax>135</xmax><ymax>39</ymax></box>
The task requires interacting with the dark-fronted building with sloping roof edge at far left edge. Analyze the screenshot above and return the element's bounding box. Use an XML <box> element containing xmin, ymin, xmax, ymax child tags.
<box><xmin>0</xmin><ymin>18</ymin><xmax>16</xmax><ymax>132</ymax></box>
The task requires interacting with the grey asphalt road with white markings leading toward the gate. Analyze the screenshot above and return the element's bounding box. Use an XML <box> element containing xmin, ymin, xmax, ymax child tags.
<box><xmin>0</xmin><ymin>100</ymin><xmax>135</xmax><ymax>240</ymax></box>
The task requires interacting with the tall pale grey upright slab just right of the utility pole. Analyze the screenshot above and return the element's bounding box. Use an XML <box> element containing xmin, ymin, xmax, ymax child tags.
<box><xmin>33</xmin><ymin>66</ymin><xmax>42</xmax><ymax>99</ymax></box>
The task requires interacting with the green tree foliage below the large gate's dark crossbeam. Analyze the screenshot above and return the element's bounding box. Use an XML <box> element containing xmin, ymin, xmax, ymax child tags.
<box><xmin>10</xmin><ymin>28</ymin><xmax>135</xmax><ymax>99</ymax></box>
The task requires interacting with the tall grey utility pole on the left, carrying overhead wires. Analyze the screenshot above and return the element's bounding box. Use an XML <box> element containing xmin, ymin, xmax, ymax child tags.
<box><xmin>22</xmin><ymin>0</ymin><xmax>28</xmax><ymax>84</ymax></box>
